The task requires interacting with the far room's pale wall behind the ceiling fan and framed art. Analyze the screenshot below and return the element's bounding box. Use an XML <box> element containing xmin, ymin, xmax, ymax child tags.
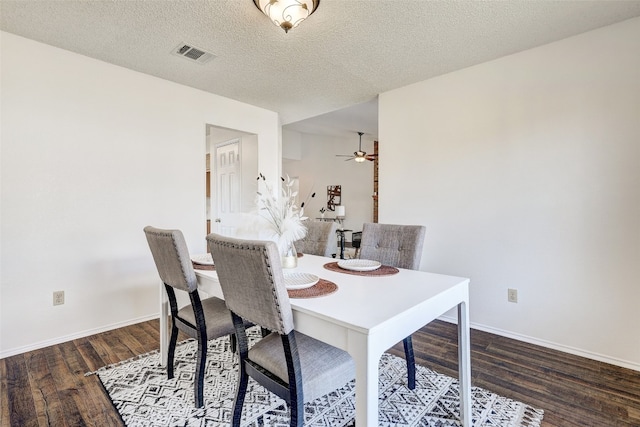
<box><xmin>282</xmin><ymin>131</ymin><xmax>373</xmax><ymax>236</ymax></box>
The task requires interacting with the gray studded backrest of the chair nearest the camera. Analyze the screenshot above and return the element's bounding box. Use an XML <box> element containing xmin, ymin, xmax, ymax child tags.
<box><xmin>207</xmin><ymin>233</ymin><xmax>293</xmax><ymax>335</ymax></box>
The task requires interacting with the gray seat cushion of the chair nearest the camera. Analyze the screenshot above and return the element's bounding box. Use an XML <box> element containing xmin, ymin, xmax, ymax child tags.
<box><xmin>249</xmin><ymin>332</ymin><xmax>355</xmax><ymax>402</ymax></box>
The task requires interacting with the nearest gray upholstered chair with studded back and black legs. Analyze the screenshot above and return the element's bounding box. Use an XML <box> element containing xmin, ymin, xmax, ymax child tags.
<box><xmin>207</xmin><ymin>234</ymin><xmax>355</xmax><ymax>426</ymax></box>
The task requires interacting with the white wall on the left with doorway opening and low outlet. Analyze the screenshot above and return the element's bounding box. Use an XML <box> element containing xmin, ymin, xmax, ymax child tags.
<box><xmin>0</xmin><ymin>32</ymin><xmax>281</xmax><ymax>357</ymax></box>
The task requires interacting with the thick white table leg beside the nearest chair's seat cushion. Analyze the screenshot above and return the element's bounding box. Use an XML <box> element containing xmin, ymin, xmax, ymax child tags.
<box><xmin>348</xmin><ymin>331</ymin><xmax>382</xmax><ymax>426</ymax></box>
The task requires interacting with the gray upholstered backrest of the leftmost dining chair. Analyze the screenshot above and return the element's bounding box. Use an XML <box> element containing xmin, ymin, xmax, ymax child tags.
<box><xmin>144</xmin><ymin>226</ymin><xmax>198</xmax><ymax>292</ymax></box>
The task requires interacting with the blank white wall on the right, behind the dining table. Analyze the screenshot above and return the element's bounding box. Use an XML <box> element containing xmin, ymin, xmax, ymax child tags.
<box><xmin>379</xmin><ymin>18</ymin><xmax>640</xmax><ymax>369</ymax></box>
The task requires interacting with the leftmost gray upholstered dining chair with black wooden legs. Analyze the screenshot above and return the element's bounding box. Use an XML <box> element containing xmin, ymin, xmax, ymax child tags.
<box><xmin>144</xmin><ymin>226</ymin><xmax>235</xmax><ymax>408</ymax></box>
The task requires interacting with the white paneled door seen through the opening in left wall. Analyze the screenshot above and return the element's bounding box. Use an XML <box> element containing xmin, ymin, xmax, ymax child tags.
<box><xmin>212</xmin><ymin>139</ymin><xmax>242</xmax><ymax>236</ymax></box>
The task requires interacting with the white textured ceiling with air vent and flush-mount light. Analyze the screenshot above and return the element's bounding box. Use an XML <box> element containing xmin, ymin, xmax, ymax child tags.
<box><xmin>0</xmin><ymin>0</ymin><xmax>640</xmax><ymax>139</ymax></box>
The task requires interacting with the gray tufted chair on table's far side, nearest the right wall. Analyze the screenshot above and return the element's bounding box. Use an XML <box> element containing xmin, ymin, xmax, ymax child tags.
<box><xmin>360</xmin><ymin>223</ymin><xmax>426</xmax><ymax>390</ymax></box>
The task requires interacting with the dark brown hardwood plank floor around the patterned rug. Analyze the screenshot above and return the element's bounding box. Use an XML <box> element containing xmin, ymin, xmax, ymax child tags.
<box><xmin>0</xmin><ymin>320</ymin><xmax>640</xmax><ymax>427</ymax></box>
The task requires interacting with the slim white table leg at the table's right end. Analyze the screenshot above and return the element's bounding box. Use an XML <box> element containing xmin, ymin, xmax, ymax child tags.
<box><xmin>458</xmin><ymin>302</ymin><xmax>471</xmax><ymax>427</ymax></box>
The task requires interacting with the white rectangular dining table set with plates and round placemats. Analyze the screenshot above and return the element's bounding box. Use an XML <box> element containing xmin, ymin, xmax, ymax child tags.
<box><xmin>160</xmin><ymin>254</ymin><xmax>471</xmax><ymax>426</ymax></box>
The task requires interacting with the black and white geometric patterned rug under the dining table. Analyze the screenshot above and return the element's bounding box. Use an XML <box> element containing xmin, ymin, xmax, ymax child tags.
<box><xmin>87</xmin><ymin>331</ymin><xmax>543</xmax><ymax>427</ymax></box>
